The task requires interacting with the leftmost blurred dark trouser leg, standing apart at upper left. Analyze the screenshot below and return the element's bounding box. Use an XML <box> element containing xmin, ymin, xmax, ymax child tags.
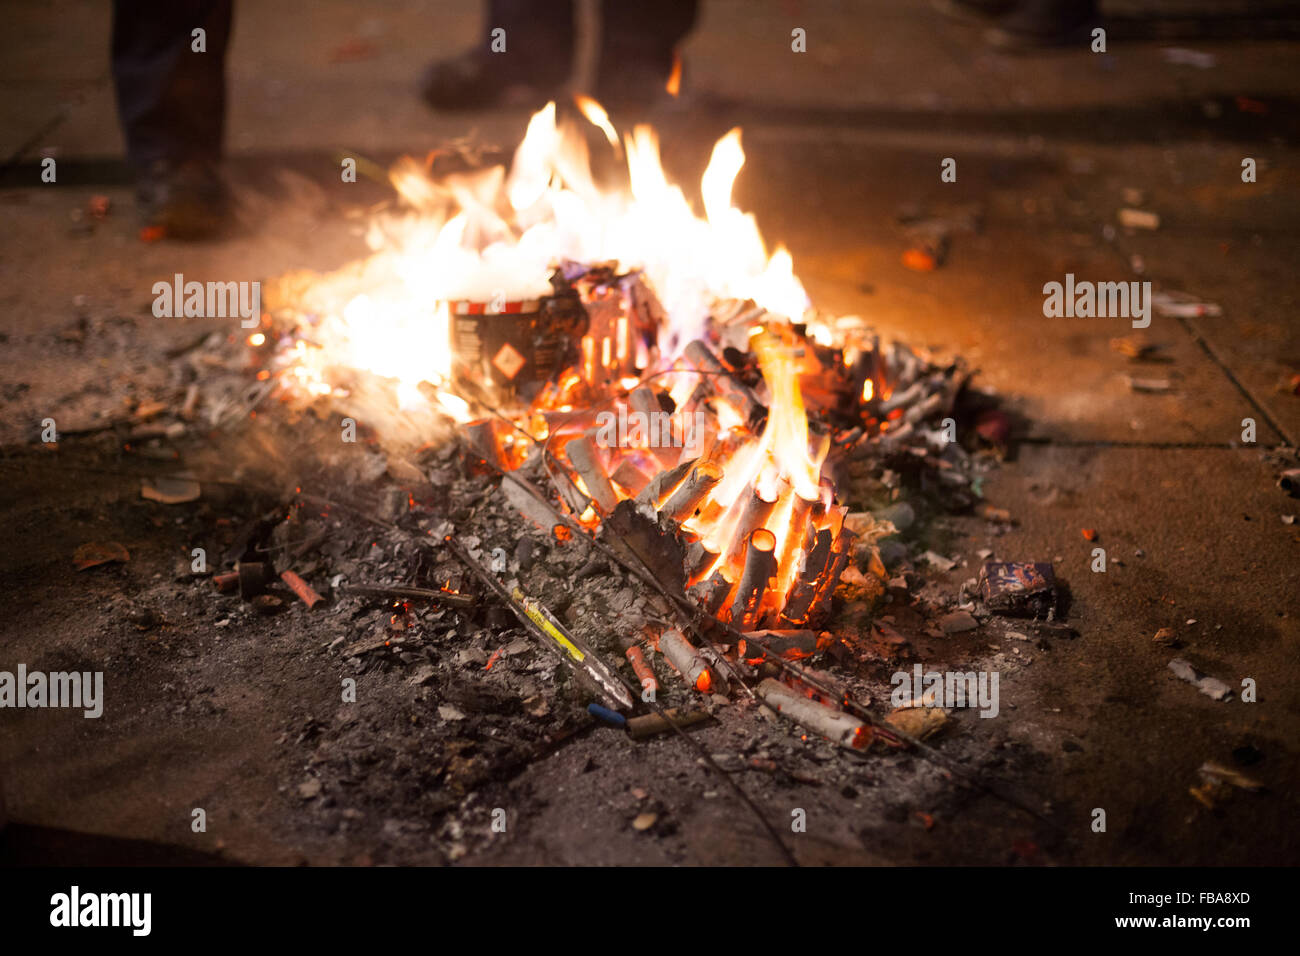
<box><xmin>112</xmin><ymin>0</ymin><xmax>233</xmax><ymax>172</ymax></box>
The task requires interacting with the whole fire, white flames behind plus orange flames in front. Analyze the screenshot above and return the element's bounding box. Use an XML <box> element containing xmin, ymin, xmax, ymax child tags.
<box><xmin>269</xmin><ymin>96</ymin><xmax>874</xmax><ymax>627</ymax></box>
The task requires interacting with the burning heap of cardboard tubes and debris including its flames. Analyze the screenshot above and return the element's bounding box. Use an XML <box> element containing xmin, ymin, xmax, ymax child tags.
<box><xmin>202</xmin><ymin>101</ymin><xmax>998</xmax><ymax>770</ymax></box>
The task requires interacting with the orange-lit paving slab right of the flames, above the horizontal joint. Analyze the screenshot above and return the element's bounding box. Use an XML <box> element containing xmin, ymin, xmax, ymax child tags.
<box><xmin>737</xmin><ymin>135</ymin><xmax>1300</xmax><ymax>445</ymax></box>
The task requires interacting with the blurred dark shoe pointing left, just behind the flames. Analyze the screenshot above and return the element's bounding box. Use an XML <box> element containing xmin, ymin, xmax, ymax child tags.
<box><xmin>420</xmin><ymin>49</ymin><xmax>569</xmax><ymax>109</ymax></box>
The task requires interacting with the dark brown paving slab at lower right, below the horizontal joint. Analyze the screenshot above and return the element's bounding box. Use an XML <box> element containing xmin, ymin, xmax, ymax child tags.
<box><xmin>953</xmin><ymin>446</ymin><xmax>1300</xmax><ymax>865</ymax></box>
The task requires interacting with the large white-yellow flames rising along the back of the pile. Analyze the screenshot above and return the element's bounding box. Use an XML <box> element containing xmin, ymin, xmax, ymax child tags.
<box><xmin>271</xmin><ymin>98</ymin><xmax>809</xmax><ymax>408</ymax></box>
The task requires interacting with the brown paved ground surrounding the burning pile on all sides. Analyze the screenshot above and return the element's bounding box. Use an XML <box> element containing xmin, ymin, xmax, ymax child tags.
<box><xmin>0</xmin><ymin>3</ymin><xmax>1300</xmax><ymax>865</ymax></box>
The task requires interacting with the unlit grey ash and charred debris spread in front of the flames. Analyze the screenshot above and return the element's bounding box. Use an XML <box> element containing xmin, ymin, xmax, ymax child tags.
<box><xmin>124</xmin><ymin>297</ymin><xmax>1066</xmax><ymax>860</ymax></box>
